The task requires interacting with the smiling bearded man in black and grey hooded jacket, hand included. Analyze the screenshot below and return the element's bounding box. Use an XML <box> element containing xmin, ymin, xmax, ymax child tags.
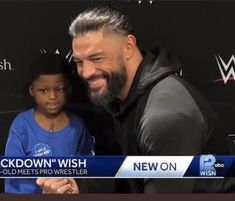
<box><xmin>37</xmin><ymin>8</ymin><xmax>233</xmax><ymax>193</ymax></box>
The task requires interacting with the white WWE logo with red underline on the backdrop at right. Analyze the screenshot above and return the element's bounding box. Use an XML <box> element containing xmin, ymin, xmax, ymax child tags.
<box><xmin>215</xmin><ymin>55</ymin><xmax>235</xmax><ymax>84</ymax></box>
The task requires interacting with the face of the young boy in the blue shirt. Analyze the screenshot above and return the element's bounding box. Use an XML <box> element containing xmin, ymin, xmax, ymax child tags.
<box><xmin>29</xmin><ymin>74</ymin><xmax>68</xmax><ymax>115</ymax></box>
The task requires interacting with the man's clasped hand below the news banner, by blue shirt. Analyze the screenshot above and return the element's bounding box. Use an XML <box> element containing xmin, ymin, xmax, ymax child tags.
<box><xmin>36</xmin><ymin>178</ymin><xmax>79</xmax><ymax>194</ymax></box>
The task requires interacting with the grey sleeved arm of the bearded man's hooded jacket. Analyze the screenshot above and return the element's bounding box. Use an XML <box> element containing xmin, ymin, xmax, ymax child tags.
<box><xmin>137</xmin><ymin>78</ymin><xmax>208</xmax><ymax>193</ymax></box>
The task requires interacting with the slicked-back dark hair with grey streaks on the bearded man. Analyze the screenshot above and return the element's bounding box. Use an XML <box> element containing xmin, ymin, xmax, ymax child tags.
<box><xmin>69</xmin><ymin>7</ymin><xmax>133</xmax><ymax>37</ymax></box>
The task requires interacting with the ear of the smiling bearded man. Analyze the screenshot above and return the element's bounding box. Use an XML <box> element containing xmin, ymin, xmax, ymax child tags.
<box><xmin>124</xmin><ymin>35</ymin><xmax>136</xmax><ymax>60</ymax></box>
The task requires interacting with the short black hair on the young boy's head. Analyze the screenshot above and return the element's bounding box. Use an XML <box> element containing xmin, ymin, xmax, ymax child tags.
<box><xmin>28</xmin><ymin>54</ymin><xmax>72</xmax><ymax>85</ymax></box>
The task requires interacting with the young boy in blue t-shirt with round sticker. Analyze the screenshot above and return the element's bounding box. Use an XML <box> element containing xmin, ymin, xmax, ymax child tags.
<box><xmin>5</xmin><ymin>54</ymin><xmax>94</xmax><ymax>194</ymax></box>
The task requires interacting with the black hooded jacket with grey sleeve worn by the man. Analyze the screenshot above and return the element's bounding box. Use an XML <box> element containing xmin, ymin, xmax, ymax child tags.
<box><xmin>108</xmin><ymin>49</ymin><xmax>233</xmax><ymax>193</ymax></box>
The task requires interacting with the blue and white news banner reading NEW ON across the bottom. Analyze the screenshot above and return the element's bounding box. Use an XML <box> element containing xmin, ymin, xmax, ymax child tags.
<box><xmin>0</xmin><ymin>155</ymin><xmax>235</xmax><ymax>178</ymax></box>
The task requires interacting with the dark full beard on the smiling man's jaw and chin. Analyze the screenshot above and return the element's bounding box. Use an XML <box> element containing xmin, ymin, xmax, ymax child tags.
<box><xmin>87</xmin><ymin>58</ymin><xmax>127</xmax><ymax>108</ymax></box>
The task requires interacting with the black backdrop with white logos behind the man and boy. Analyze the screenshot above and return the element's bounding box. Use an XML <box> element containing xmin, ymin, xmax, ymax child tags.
<box><xmin>0</xmin><ymin>0</ymin><xmax>235</xmax><ymax>193</ymax></box>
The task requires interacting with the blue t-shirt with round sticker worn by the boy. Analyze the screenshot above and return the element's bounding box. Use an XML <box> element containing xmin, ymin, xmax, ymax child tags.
<box><xmin>5</xmin><ymin>109</ymin><xmax>94</xmax><ymax>194</ymax></box>
